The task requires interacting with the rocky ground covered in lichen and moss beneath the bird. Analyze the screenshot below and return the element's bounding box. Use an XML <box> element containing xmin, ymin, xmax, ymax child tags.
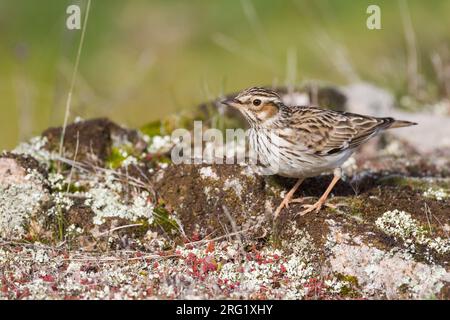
<box><xmin>0</xmin><ymin>87</ymin><xmax>450</xmax><ymax>299</ymax></box>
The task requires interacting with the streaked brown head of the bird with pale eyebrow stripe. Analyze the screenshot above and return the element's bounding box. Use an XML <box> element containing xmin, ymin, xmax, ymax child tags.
<box><xmin>222</xmin><ymin>87</ymin><xmax>283</xmax><ymax>126</ymax></box>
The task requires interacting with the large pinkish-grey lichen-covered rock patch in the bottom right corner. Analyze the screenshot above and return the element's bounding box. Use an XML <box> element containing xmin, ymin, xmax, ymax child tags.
<box><xmin>327</xmin><ymin>223</ymin><xmax>450</xmax><ymax>299</ymax></box>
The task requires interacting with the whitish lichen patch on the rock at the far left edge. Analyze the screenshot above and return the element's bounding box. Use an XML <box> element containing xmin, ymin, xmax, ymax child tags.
<box><xmin>0</xmin><ymin>169</ymin><xmax>49</xmax><ymax>239</ymax></box>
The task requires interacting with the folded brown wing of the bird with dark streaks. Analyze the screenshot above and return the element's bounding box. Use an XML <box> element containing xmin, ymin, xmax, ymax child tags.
<box><xmin>290</xmin><ymin>107</ymin><xmax>395</xmax><ymax>155</ymax></box>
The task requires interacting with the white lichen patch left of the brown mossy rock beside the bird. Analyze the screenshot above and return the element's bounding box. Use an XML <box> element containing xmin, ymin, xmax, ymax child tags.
<box><xmin>85</xmin><ymin>175</ymin><xmax>154</xmax><ymax>225</ymax></box>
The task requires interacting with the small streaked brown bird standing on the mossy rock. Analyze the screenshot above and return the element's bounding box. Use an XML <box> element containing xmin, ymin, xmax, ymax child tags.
<box><xmin>222</xmin><ymin>87</ymin><xmax>416</xmax><ymax>218</ymax></box>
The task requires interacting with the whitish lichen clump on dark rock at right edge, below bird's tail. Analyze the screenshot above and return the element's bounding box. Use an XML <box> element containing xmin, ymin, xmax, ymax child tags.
<box><xmin>375</xmin><ymin>209</ymin><xmax>450</xmax><ymax>254</ymax></box>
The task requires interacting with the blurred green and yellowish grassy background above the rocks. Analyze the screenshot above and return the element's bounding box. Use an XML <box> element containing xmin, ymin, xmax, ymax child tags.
<box><xmin>0</xmin><ymin>0</ymin><xmax>450</xmax><ymax>150</ymax></box>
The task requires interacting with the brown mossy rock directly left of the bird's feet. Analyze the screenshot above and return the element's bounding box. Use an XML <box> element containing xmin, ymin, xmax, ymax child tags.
<box><xmin>154</xmin><ymin>164</ymin><xmax>271</xmax><ymax>237</ymax></box>
